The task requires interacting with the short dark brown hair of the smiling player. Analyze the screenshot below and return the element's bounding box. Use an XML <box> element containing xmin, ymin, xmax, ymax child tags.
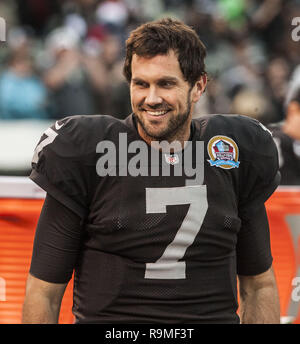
<box><xmin>123</xmin><ymin>18</ymin><xmax>206</xmax><ymax>86</ymax></box>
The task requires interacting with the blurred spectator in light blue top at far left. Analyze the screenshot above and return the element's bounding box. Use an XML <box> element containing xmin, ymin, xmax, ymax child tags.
<box><xmin>0</xmin><ymin>29</ymin><xmax>48</xmax><ymax>119</ymax></box>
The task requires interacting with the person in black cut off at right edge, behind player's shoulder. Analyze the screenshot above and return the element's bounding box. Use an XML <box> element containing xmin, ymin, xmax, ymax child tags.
<box><xmin>269</xmin><ymin>65</ymin><xmax>300</xmax><ymax>185</ymax></box>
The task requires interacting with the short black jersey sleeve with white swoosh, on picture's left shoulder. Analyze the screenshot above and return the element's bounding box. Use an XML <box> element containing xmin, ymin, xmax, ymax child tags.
<box><xmin>30</xmin><ymin>116</ymin><xmax>89</xmax><ymax>218</ymax></box>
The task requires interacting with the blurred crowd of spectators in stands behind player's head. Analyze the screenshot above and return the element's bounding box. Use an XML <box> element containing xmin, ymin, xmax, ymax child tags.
<box><xmin>0</xmin><ymin>0</ymin><xmax>300</xmax><ymax>124</ymax></box>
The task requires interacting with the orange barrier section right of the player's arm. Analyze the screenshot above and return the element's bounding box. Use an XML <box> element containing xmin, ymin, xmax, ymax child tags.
<box><xmin>266</xmin><ymin>187</ymin><xmax>300</xmax><ymax>324</ymax></box>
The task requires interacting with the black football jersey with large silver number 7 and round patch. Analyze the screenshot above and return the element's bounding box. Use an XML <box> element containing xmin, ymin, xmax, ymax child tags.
<box><xmin>31</xmin><ymin>115</ymin><xmax>279</xmax><ymax>323</ymax></box>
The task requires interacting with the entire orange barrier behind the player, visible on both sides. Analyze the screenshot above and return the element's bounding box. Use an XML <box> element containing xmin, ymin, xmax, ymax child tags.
<box><xmin>0</xmin><ymin>188</ymin><xmax>300</xmax><ymax>324</ymax></box>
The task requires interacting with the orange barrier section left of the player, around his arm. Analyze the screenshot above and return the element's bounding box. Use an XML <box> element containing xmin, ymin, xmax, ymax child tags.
<box><xmin>0</xmin><ymin>199</ymin><xmax>73</xmax><ymax>324</ymax></box>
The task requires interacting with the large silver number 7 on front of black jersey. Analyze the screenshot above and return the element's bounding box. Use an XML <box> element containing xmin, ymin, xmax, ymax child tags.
<box><xmin>145</xmin><ymin>185</ymin><xmax>208</xmax><ymax>279</ymax></box>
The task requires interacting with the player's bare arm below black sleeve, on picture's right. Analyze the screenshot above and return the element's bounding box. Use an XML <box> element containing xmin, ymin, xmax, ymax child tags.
<box><xmin>239</xmin><ymin>267</ymin><xmax>280</xmax><ymax>324</ymax></box>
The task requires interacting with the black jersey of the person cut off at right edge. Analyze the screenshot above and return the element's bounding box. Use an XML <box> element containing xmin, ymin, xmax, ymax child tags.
<box><xmin>269</xmin><ymin>123</ymin><xmax>300</xmax><ymax>185</ymax></box>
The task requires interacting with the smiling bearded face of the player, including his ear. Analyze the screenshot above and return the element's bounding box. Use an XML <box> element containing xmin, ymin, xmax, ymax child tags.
<box><xmin>130</xmin><ymin>50</ymin><xmax>206</xmax><ymax>143</ymax></box>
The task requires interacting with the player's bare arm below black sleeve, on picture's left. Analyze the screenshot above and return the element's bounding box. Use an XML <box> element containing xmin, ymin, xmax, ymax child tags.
<box><xmin>22</xmin><ymin>274</ymin><xmax>67</xmax><ymax>324</ymax></box>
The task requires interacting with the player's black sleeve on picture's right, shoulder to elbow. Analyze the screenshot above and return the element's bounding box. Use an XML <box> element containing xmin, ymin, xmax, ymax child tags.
<box><xmin>236</xmin><ymin>119</ymin><xmax>280</xmax><ymax>275</ymax></box>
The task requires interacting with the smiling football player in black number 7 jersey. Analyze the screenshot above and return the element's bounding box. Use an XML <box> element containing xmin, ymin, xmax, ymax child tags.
<box><xmin>23</xmin><ymin>19</ymin><xmax>280</xmax><ymax>324</ymax></box>
